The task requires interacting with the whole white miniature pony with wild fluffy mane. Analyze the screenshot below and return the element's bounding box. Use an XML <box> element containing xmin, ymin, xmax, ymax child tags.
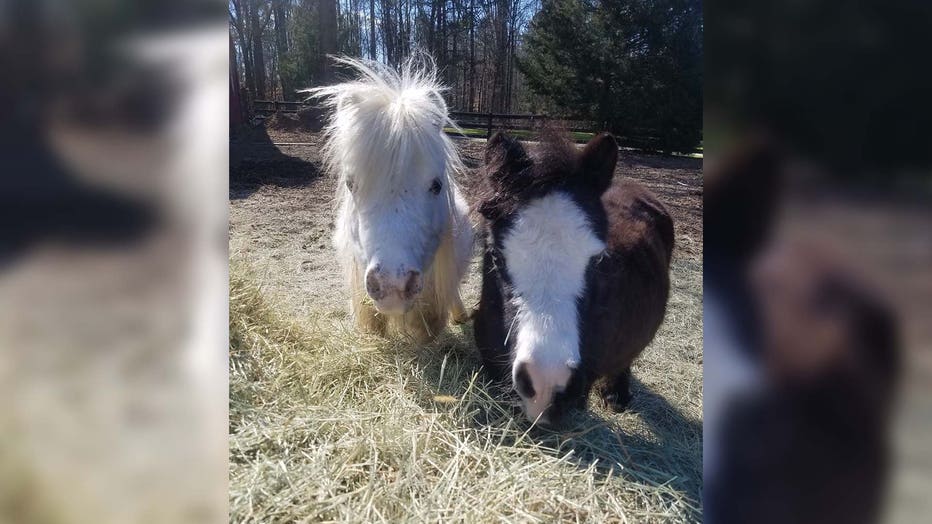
<box><xmin>304</xmin><ymin>58</ymin><xmax>473</xmax><ymax>341</ymax></box>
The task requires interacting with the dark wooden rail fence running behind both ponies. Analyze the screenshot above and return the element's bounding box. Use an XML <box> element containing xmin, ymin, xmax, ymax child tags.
<box><xmin>253</xmin><ymin>100</ymin><xmax>661</xmax><ymax>149</ymax></box>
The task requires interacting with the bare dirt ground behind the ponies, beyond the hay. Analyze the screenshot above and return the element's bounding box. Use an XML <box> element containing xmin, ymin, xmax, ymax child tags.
<box><xmin>230</xmin><ymin>128</ymin><xmax>702</xmax><ymax>317</ymax></box>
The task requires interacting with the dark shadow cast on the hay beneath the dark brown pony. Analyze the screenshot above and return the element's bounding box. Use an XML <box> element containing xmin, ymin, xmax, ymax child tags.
<box><xmin>396</xmin><ymin>326</ymin><xmax>702</xmax><ymax>516</ymax></box>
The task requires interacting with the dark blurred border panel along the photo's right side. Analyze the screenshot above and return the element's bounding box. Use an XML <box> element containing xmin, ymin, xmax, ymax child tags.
<box><xmin>704</xmin><ymin>0</ymin><xmax>932</xmax><ymax>522</ymax></box>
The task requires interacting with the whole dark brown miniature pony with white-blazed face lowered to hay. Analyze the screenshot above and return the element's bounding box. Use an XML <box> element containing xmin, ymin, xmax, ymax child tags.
<box><xmin>475</xmin><ymin>134</ymin><xmax>673</xmax><ymax>424</ymax></box>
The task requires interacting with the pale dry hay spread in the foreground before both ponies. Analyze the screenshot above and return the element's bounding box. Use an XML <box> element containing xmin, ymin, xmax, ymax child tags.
<box><xmin>230</xmin><ymin>247</ymin><xmax>702</xmax><ymax>522</ymax></box>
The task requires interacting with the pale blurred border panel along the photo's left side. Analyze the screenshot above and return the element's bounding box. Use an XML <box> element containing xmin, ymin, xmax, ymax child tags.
<box><xmin>0</xmin><ymin>0</ymin><xmax>229</xmax><ymax>522</ymax></box>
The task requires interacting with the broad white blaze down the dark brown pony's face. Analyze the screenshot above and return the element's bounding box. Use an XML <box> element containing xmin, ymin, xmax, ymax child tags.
<box><xmin>502</xmin><ymin>192</ymin><xmax>605</xmax><ymax>422</ymax></box>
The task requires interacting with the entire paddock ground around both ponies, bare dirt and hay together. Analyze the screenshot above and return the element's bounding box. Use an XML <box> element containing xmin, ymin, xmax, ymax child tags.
<box><xmin>229</xmin><ymin>125</ymin><xmax>702</xmax><ymax>522</ymax></box>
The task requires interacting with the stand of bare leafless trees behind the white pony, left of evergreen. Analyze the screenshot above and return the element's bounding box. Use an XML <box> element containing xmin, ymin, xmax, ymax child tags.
<box><xmin>229</xmin><ymin>0</ymin><xmax>540</xmax><ymax>112</ymax></box>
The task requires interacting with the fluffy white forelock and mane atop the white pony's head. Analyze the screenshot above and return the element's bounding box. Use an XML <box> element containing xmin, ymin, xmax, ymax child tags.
<box><xmin>301</xmin><ymin>55</ymin><xmax>462</xmax><ymax>200</ymax></box>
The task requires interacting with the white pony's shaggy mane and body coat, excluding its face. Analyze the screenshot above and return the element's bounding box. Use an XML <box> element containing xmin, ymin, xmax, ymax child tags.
<box><xmin>302</xmin><ymin>55</ymin><xmax>473</xmax><ymax>340</ymax></box>
